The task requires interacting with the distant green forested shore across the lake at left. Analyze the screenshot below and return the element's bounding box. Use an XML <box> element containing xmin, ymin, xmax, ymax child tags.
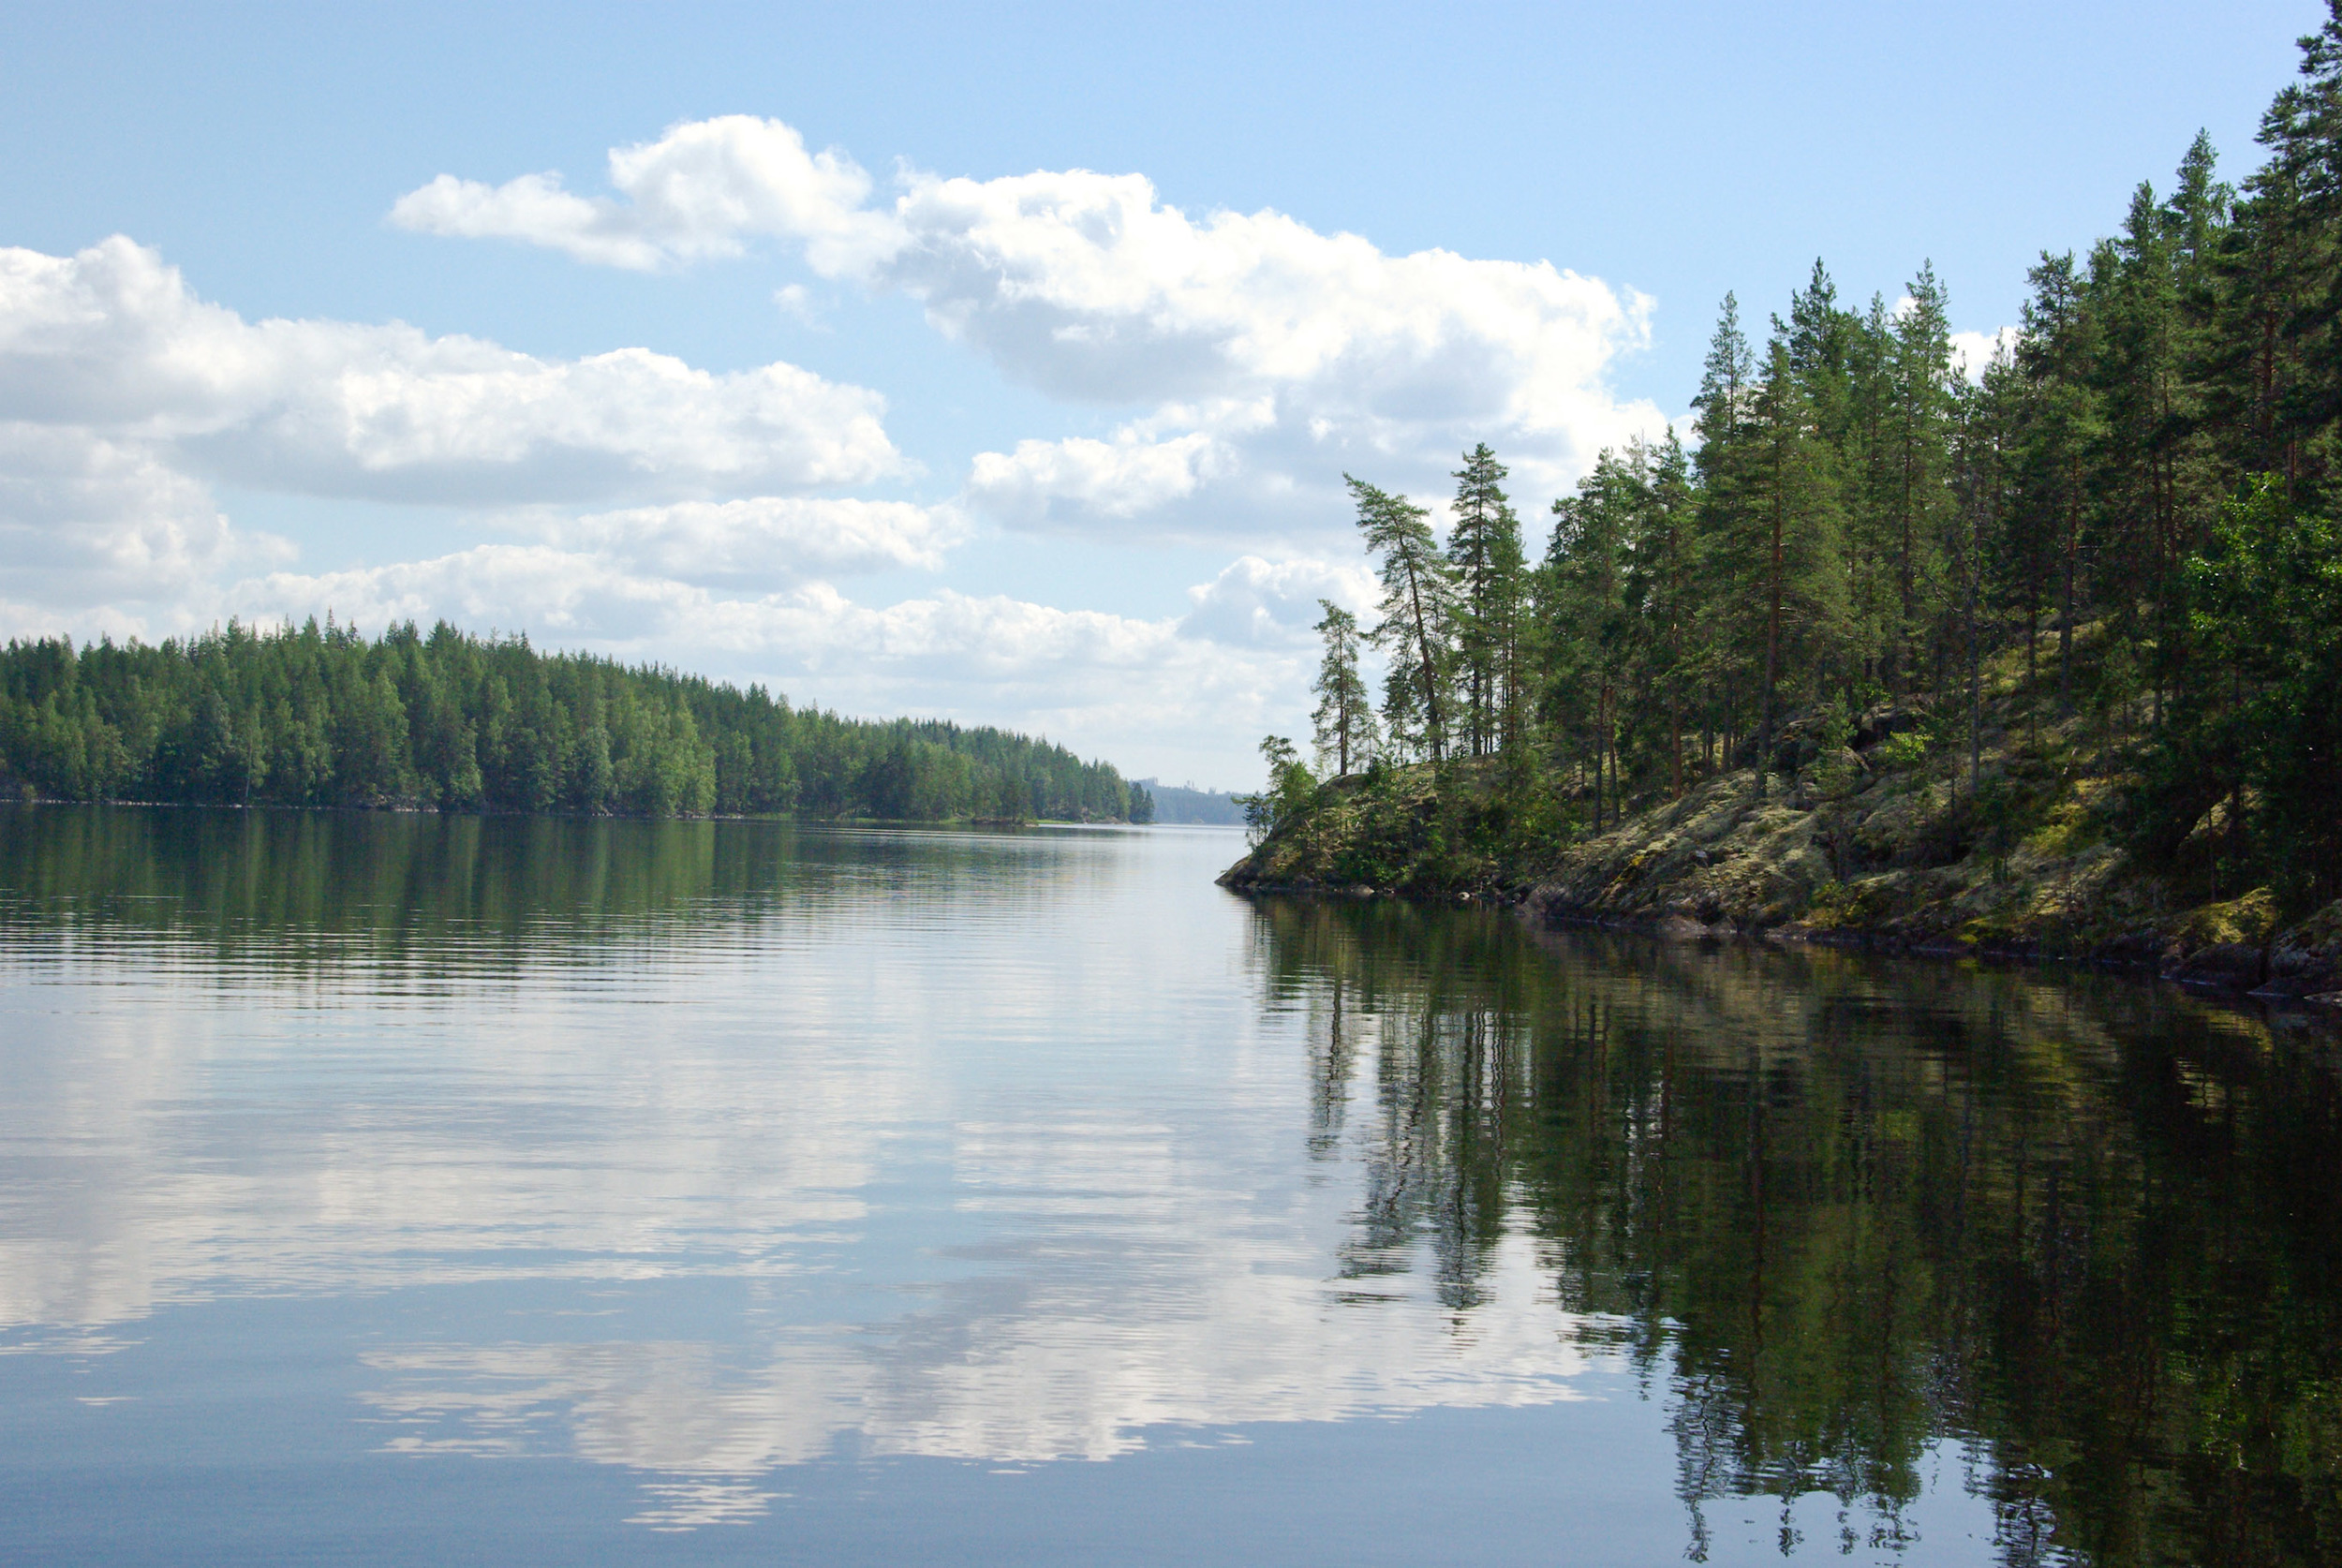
<box><xmin>0</xmin><ymin>620</ymin><xmax>1152</xmax><ymax>821</ymax></box>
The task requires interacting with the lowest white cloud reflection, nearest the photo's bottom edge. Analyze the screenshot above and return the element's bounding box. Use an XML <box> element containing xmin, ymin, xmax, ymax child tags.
<box><xmin>347</xmin><ymin>1235</ymin><xmax>1586</xmax><ymax>1505</ymax></box>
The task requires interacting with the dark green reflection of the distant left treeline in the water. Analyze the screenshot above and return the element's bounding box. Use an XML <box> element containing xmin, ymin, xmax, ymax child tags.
<box><xmin>0</xmin><ymin>805</ymin><xmax>1096</xmax><ymax>969</ymax></box>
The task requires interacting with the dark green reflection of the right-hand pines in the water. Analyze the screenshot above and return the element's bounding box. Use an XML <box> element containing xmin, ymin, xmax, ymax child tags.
<box><xmin>1260</xmin><ymin>903</ymin><xmax>2342</xmax><ymax>1563</ymax></box>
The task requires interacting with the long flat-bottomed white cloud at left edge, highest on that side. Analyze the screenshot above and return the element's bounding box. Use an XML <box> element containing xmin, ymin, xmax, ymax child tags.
<box><xmin>0</xmin><ymin>236</ymin><xmax>902</xmax><ymax>503</ymax></box>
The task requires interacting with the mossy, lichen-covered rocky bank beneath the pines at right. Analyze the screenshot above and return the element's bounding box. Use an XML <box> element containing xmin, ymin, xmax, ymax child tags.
<box><xmin>1221</xmin><ymin>759</ymin><xmax>2342</xmax><ymax>1013</ymax></box>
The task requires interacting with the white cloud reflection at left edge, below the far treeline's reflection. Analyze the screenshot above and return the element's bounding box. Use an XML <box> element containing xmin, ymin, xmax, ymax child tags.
<box><xmin>0</xmin><ymin>922</ymin><xmax>895</xmax><ymax>1327</ymax></box>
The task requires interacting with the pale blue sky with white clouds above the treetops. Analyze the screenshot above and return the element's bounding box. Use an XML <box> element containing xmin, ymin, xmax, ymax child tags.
<box><xmin>0</xmin><ymin>0</ymin><xmax>2323</xmax><ymax>789</ymax></box>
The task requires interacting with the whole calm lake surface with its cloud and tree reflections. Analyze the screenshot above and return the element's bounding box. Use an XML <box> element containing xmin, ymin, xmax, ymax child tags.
<box><xmin>0</xmin><ymin>807</ymin><xmax>2342</xmax><ymax>1563</ymax></box>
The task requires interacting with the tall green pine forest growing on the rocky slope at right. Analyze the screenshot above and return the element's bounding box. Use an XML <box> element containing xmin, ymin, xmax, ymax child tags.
<box><xmin>1253</xmin><ymin>5</ymin><xmax>2342</xmax><ymax>908</ymax></box>
